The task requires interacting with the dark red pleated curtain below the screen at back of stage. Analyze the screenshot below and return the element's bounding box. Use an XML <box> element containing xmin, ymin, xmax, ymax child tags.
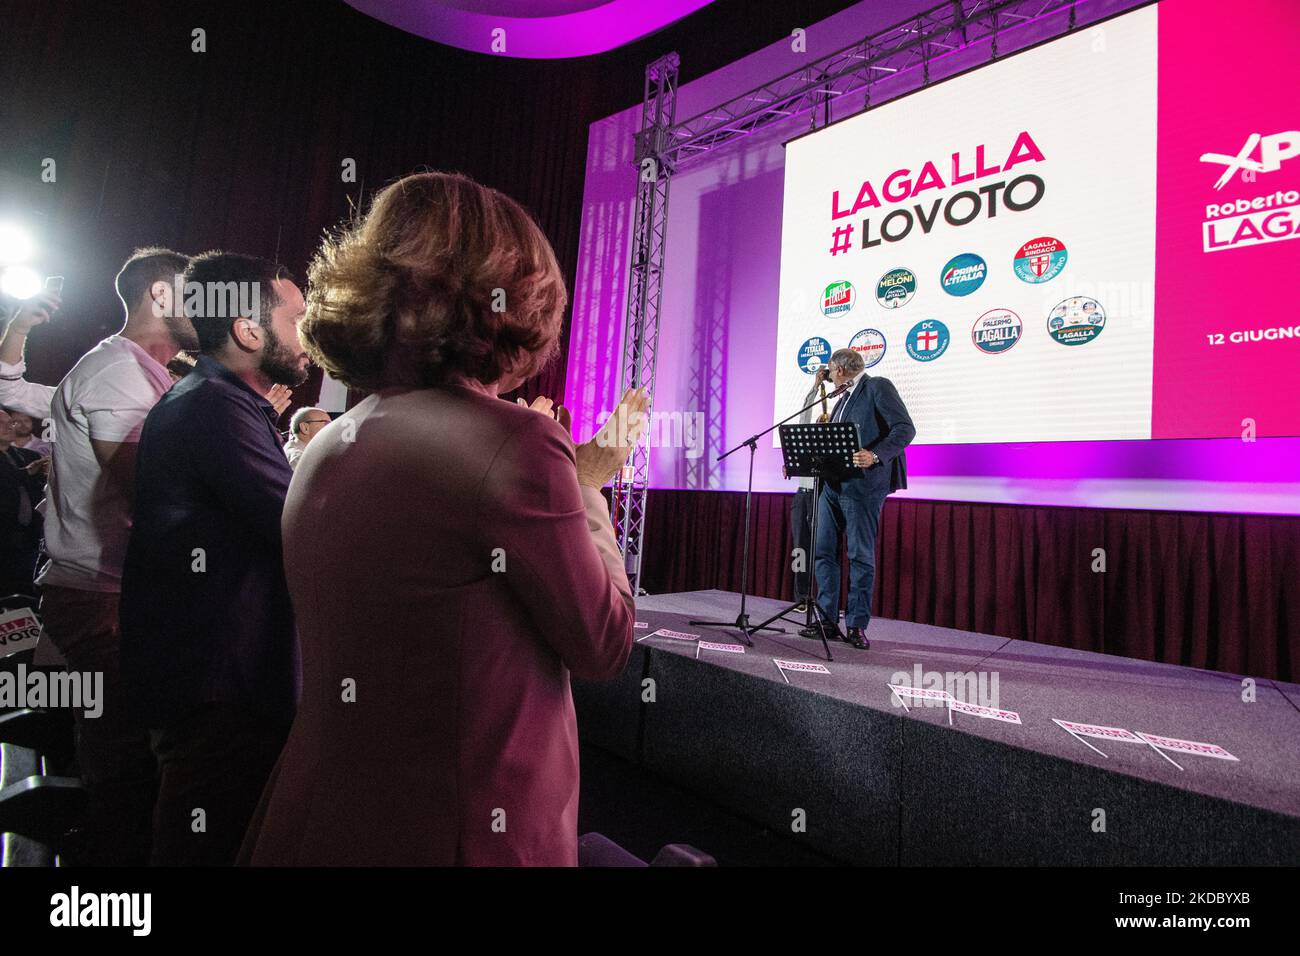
<box><xmin>641</xmin><ymin>490</ymin><xmax>1300</xmax><ymax>680</ymax></box>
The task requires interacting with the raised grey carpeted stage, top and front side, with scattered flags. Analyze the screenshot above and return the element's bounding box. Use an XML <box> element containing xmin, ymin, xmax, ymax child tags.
<box><xmin>573</xmin><ymin>591</ymin><xmax>1300</xmax><ymax>866</ymax></box>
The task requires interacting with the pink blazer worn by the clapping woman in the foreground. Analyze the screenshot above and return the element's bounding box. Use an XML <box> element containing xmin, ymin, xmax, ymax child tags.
<box><xmin>241</xmin><ymin>385</ymin><xmax>634</xmax><ymax>866</ymax></box>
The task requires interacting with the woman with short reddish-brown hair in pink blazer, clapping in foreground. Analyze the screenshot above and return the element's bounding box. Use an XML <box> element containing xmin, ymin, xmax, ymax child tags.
<box><xmin>241</xmin><ymin>173</ymin><xmax>647</xmax><ymax>865</ymax></box>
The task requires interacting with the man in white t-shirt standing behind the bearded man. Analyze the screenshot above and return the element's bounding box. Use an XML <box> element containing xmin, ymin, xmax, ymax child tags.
<box><xmin>24</xmin><ymin>248</ymin><xmax>198</xmax><ymax>865</ymax></box>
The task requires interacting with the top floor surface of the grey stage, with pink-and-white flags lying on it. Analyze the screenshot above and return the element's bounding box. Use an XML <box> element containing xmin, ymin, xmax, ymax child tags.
<box><xmin>637</xmin><ymin>591</ymin><xmax>1300</xmax><ymax>817</ymax></box>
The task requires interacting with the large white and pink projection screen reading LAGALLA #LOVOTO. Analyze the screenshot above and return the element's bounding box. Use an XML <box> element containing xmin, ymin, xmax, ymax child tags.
<box><xmin>775</xmin><ymin>5</ymin><xmax>1300</xmax><ymax>444</ymax></box>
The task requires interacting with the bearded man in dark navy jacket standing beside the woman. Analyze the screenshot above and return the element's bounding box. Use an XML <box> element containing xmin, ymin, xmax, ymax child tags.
<box><xmin>122</xmin><ymin>252</ymin><xmax>308</xmax><ymax>866</ymax></box>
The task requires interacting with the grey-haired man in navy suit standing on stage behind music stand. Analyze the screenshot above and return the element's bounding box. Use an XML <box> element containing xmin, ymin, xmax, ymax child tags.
<box><xmin>806</xmin><ymin>349</ymin><xmax>917</xmax><ymax>650</ymax></box>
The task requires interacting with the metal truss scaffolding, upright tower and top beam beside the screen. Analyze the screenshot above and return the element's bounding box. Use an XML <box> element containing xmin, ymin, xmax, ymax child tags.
<box><xmin>611</xmin><ymin>0</ymin><xmax>1102</xmax><ymax>593</ymax></box>
